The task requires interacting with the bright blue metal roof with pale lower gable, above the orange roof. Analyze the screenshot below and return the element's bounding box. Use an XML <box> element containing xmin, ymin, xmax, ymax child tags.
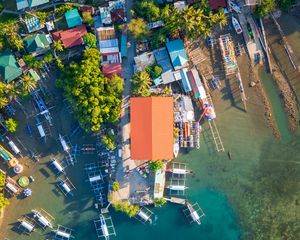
<box><xmin>166</xmin><ymin>39</ymin><xmax>188</xmax><ymax>70</ymax></box>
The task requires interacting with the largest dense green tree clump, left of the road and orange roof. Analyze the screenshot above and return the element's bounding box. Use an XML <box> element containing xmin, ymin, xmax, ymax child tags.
<box><xmin>57</xmin><ymin>48</ymin><xmax>123</xmax><ymax>131</ymax></box>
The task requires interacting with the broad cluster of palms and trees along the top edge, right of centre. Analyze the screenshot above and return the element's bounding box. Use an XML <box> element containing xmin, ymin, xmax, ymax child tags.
<box><xmin>128</xmin><ymin>0</ymin><xmax>227</xmax><ymax>48</ymax></box>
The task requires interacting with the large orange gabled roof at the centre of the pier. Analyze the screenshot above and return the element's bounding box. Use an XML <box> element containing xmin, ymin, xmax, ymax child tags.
<box><xmin>130</xmin><ymin>97</ymin><xmax>173</xmax><ymax>160</ymax></box>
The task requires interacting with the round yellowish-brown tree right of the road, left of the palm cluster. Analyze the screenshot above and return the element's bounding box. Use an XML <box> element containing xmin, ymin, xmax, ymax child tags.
<box><xmin>128</xmin><ymin>18</ymin><xmax>150</xmax><ymax>41</ymax></box>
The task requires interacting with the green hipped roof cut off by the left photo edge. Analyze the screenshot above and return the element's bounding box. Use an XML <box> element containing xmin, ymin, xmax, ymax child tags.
<box><xmin>0</xmin><ymin>50</ymin><xmax>22</xmax><ymax>83</ymax></box>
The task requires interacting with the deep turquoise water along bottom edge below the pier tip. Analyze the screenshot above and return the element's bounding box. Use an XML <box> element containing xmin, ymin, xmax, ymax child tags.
<box><xmin>107</xmin><ymin>189</ymin><xmax>240</xmax><ymax>240</ymax></box>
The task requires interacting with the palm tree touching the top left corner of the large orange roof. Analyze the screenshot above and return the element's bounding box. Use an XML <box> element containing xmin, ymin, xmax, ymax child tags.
<box><xmin>131</xmin><ymin>71</ymin><xmax>151</xmax><ymax>97</ymax></box>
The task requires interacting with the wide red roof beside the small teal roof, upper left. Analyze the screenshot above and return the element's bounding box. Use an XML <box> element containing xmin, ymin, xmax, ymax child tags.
<box><xmin>52</xmin><ymin>25</ymin><xmax>87</xmax><ymax>48</ymax></box>
